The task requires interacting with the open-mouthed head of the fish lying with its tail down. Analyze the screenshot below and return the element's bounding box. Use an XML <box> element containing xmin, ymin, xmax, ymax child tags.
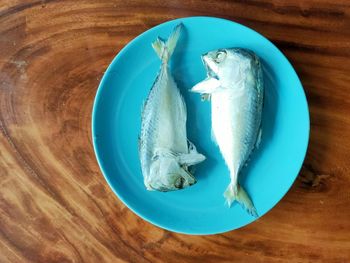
<box><xmin>202</xmin><ymin>48</ymin><xmax>257</xmax><ymax>86</ymax></box>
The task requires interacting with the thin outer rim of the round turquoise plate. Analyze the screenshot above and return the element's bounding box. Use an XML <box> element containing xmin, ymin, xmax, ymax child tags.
<box><xmin>91</xmin><ymin>16</ymin><xmax>310</xmax><ymax>235</ymax></box>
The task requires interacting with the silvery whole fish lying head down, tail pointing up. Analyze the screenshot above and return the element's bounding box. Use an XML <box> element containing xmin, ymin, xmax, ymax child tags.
<box><xmin>139</xmin><ymin>24</ymin><xmax>205</xmax><ymax>191</ymax></box>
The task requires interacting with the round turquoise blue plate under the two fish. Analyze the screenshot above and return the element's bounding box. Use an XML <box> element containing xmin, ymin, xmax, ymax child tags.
<box><xmin>92</xmin><ymin>17</ymin><xmax>310</xmax><ymax>234</ymax></box>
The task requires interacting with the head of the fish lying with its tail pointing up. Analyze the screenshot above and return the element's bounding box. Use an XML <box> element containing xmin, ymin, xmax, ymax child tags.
<box><xmin>145</xmin><ymin>157</ymin><xmax>196</xmax><ymax>192</ymax></box>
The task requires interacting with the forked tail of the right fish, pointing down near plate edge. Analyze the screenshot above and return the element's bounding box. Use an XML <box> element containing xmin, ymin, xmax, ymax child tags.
<box><xmin>224</xmin><ymin>183</ymin><xmax>258</xmax><ymax>217</ymax></box>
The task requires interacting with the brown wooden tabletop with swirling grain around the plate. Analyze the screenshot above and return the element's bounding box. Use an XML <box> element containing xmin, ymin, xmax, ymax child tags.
<box><xmin>0</xmin><ymin>0</ymin><xmax>350</xmax><ymax>263</ymax></box>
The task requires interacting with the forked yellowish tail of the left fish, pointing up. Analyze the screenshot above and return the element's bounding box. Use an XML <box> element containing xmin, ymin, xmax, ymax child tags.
<box><xmin>152</xmin><ymin>23</ymin><xmax>183</xmax><ymax>64</ymax></box>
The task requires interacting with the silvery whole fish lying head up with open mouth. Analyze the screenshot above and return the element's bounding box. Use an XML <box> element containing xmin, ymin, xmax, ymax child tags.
<box><xmin>191</xmin><ymin>48</ymin><xmax>264</xmax><ymax>216</ymax></box>
